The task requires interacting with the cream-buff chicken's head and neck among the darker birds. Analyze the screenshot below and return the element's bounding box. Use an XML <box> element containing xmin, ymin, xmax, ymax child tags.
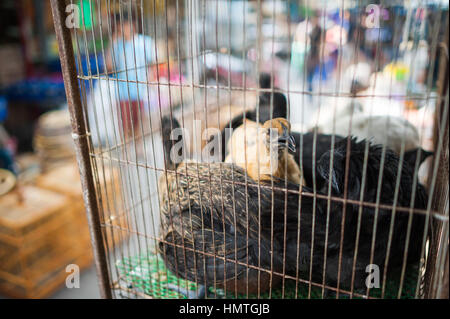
<box><xmin>225</xmin><ymin>118</ymin><xmax>304</xmax><ymax>184</ymax></box>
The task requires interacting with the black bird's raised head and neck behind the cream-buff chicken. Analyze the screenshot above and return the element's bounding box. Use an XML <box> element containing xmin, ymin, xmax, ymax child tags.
<box><xmin>213</xmin><ymin>73</ymin><xmax>287</xmax><ymax>161</ymax></box>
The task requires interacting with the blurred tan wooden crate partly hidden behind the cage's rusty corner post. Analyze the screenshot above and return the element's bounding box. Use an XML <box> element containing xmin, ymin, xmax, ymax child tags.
<box><xmin>36</xmin><ymin>162</ymin><xmax>128</xmax><ymax>248</ymax></box>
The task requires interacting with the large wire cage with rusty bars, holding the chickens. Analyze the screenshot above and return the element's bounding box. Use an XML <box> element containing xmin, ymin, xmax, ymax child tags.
<box><xmin>52</xmin><ymin>0</ymin><xmax>448</xmax><ymax>298</ymax></box>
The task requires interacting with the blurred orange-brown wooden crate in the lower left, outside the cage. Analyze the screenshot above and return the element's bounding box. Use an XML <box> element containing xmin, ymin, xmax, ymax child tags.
<box><xmin>0</xmin><ymin>186</ymin><xmax>92</xmax><ymax>298</ymax></box>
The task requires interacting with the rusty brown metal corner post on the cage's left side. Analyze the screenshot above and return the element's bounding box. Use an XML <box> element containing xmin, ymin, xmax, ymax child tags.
<box><xmin>50</xmin><ymin>0</ymin><xmax>112</xmax><ymax>299</ymax></box>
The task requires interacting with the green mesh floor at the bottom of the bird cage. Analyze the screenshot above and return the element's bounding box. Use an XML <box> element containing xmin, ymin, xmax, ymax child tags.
<box><xmin>116</xmin><ymin>252</ymin><xmax>418</xmax><ymax>299</ymax></box>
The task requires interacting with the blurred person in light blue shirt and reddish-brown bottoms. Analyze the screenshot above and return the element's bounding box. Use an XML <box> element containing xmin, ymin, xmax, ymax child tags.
<box><xmin>106</xmin><ymin>12</ymin><xmax>154</xmax><ymax>144</ymax></box>
